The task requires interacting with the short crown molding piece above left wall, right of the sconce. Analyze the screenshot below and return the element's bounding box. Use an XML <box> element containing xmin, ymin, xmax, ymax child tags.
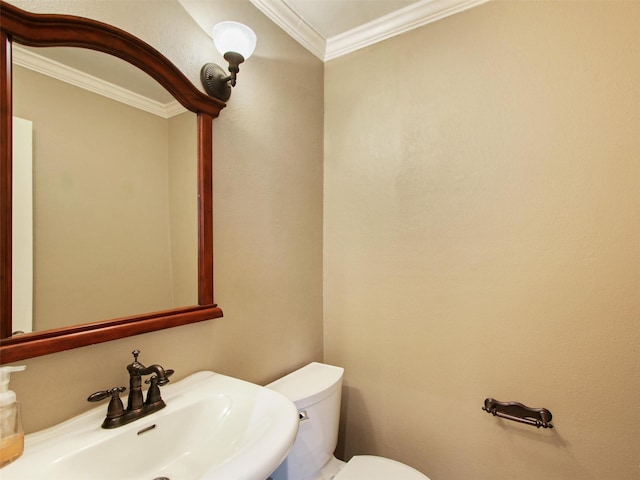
<box><xmin>250</xmin><ymin>0</ymin><xmax>326</xmax><ymax>61</ymax></box>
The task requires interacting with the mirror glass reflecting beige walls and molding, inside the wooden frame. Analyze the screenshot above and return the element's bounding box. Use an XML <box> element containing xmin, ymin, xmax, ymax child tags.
<box><xmin>13</xmin><ymin>45</ymin><xmax>198</xmax><ymax>331</ymax></box>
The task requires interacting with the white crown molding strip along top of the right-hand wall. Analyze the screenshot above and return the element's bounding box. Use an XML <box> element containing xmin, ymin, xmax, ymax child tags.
<box><xmin>324</xmin><ymin>0</ymin><xmax>490</xmax><ymax>61</ymax></box>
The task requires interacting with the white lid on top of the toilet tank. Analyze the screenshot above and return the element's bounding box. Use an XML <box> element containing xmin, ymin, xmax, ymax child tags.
<box><xmin>267</xmin><ymin>362</ymin><xmax>344</xmax><ymax>408</ymax></box>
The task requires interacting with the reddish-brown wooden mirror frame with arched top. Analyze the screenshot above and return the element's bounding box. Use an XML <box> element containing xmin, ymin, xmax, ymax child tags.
<box><xmin>0</xmin><ymin>1</ymin><xmax>225</xmax><ymax>363</ymax></box>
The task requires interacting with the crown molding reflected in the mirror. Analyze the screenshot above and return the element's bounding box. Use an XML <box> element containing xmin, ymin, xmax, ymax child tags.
<box><xmin>12</xmin><ymin>43</ymin><xmax>186</xmax><ymax>118</ymax></box>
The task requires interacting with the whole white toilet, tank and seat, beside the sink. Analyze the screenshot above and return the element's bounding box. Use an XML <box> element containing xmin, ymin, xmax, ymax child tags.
<box><xmin>267</xmin><ymin>362</ymin><xmax>429</xmax><ymax>480</ymax></box>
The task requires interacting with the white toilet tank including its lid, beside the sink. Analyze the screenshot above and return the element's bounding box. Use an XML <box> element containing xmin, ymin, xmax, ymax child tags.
<box><xmin>267</xmin><ymin>362</ymin><xmax>344</xmax><ymax>480</ymax></box>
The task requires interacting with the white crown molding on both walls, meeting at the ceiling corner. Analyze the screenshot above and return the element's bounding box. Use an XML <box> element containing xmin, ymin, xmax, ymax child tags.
<box><xmin>250</xmin><ymin>0</ymin><xmax>490</xmax><ymax>62</ymax></box>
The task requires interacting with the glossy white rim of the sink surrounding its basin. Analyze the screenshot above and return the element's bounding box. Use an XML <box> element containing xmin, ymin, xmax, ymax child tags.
<box><xmin>2</xmin><ymin>371</ymin><xmax>299</xmax><ymax>480</ymax></box>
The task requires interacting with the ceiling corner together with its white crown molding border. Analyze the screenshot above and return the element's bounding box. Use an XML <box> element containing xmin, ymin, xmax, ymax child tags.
<box><xmin>250</xmin><ymin>0</ymin><xmax>489</xmax><ymax>61</ymax></box>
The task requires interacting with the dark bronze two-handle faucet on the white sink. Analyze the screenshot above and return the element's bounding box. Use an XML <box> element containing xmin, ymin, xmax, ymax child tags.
<box><xmin>87</xmin><ymin>350</ymin><xmax>173</xmax><ymax>428</ymax></box>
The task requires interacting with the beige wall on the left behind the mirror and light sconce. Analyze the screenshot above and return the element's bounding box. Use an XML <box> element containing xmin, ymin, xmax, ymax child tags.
<box><xmin>6</xmin><ymin>0</ymin><xmax>323</xmax><ymax>432</ymax></box>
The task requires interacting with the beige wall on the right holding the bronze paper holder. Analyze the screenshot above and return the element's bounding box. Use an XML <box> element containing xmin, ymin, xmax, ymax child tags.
<box><xmin>324</xmin><ymin>2</ymin><xmax>640</xmax><ymax>480</ymax></box>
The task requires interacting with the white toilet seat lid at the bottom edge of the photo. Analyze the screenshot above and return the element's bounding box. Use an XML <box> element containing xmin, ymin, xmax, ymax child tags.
<box><xmin>334</xmin><ymin>455</ymin><xmax>429</xmax><ymax>480</ymax></box>
